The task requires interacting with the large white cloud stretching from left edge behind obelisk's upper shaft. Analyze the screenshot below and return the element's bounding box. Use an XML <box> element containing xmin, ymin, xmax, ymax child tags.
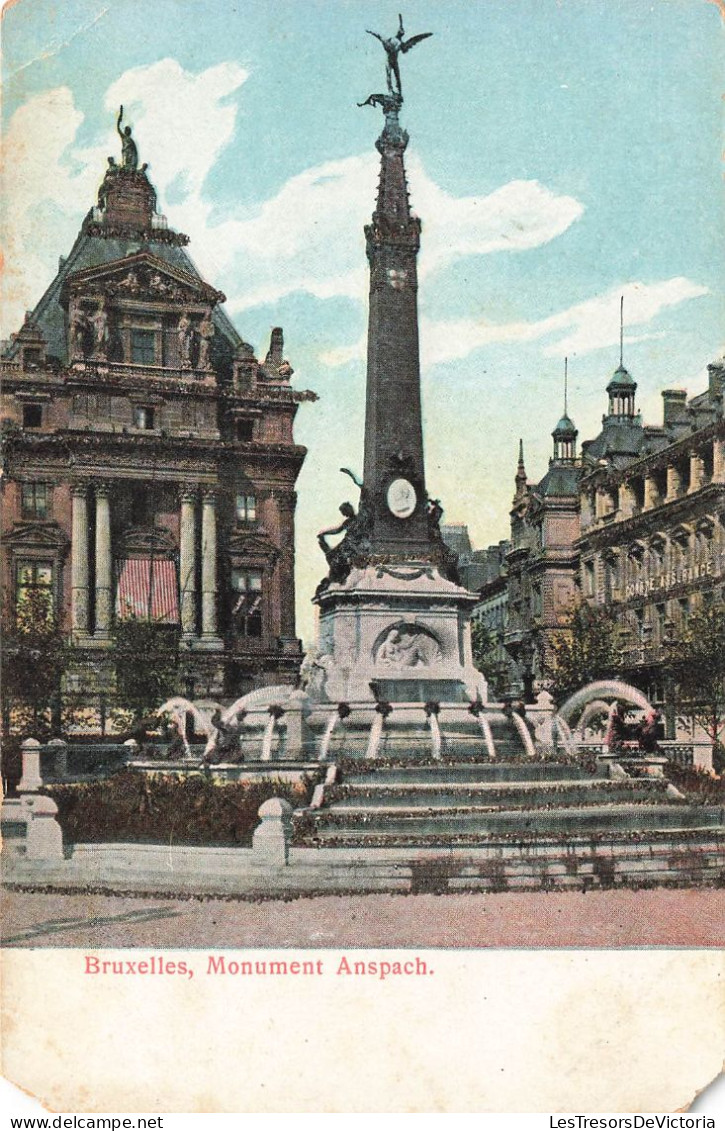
<box><xmin>1</xmin><ymin>59</ymin><xmax>584</xmax><ymax>328</ymax></box>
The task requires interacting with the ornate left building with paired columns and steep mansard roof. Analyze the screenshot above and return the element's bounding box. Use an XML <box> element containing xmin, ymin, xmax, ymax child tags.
<box><xmin>0</xmin><ymin>128</ymin><xmax>316</xmax><ymax>719</ymax></box>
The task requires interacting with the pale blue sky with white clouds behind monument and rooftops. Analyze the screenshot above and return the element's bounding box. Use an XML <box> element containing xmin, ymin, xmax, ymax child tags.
<box><xmin>0</xmin><ymin>0</ymin><xmax>724</xmax><ymax>642</ymax></box>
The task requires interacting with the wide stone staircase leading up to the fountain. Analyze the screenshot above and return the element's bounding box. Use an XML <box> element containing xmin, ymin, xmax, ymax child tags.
<box><xmin>294</xmin><ymin>760</ymin><xmax>725</xmax><ymax>890</ymax></box>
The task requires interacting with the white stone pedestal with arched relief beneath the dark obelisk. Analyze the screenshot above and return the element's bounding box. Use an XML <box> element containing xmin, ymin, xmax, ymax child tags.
<box><xmin>316</xmin><ymin>562</ymin><xmax>486</xmax><ymax>703</ymax></box>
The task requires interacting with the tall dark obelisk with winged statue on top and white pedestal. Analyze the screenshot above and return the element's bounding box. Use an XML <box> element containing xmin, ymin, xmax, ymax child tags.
<box><xmin>314</xmin><ymin>20</ymin><xmax>481</xmax><ymax>703</ymax></box>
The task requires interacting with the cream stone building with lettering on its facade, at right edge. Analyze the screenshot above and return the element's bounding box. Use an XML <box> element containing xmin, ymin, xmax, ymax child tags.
<box><xmin>576</xmin><ymin>359</ymin><xmax>725</xmax><ymax>733</ymax></box>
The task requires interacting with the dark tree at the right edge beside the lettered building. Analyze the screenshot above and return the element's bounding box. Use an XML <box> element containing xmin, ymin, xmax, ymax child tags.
<box><xmin>668</xmin><ymin>604</ymin><xmax>725</xmax><ymax>748</ymax></box>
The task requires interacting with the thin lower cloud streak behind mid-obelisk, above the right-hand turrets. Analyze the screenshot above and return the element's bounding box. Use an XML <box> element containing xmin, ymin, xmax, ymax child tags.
<box><xmin>320</xmin><ymin>276</ymin><xmax>708</xmax><ymax>368</ymax></box>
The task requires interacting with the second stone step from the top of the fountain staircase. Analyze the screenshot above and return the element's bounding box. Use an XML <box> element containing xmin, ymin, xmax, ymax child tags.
<box><xmin>326</xmin><ymin>778</ymin><xmax>684</xmax><ymax>812</ymax></box>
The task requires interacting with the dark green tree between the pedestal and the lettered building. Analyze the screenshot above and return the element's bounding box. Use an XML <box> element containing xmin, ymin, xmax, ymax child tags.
<box><xmin>544</xmin><ymin>602</ymin><xmax>621</xmax><ymax>703</ymax></box>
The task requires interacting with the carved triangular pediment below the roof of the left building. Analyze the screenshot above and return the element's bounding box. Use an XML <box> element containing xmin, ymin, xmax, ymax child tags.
<box><xmin>63</xmin><ymin>251</ymin><xmax>225</xmax><ymax>305</ymax></box>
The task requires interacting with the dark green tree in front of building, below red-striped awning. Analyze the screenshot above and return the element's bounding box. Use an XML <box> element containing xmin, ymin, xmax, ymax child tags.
<box><xmin>112</xmin><ymin>616</ymin><xmax>179</xmax><ymax>719</ymax></box>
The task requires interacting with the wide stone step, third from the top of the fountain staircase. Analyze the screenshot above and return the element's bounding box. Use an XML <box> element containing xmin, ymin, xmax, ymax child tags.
<box><xmin>305</xmin><ymin>803</ymin><xmax>724</xmax><ymax>844</ymax></box>
